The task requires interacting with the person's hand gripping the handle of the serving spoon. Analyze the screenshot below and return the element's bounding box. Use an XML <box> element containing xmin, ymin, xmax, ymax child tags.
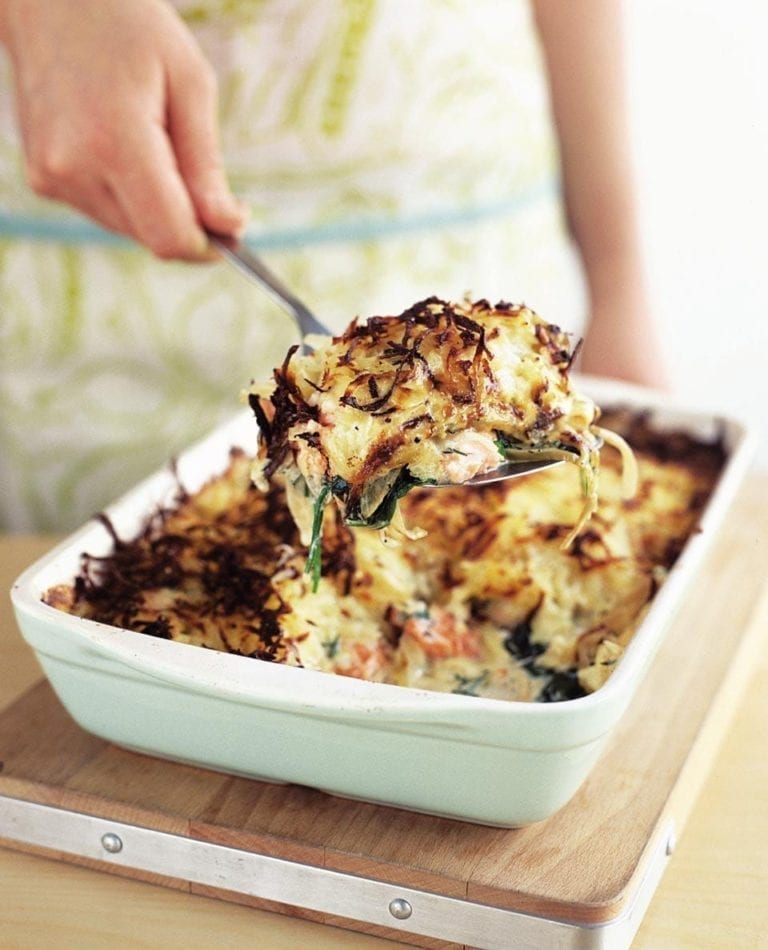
<box><xmin>0</xmin><ymin>0</ymin><xmax>246</xmax><ymax>260</ymax></box>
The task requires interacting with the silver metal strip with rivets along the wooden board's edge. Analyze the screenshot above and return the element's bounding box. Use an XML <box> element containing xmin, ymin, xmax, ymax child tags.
<box><xmin>0</xmin><ymin>796</ymin><xmax>674</xmax><ymax>950</ymax></box>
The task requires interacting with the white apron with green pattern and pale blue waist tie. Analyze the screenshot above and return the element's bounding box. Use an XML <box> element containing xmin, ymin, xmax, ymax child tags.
<box><xmin>0</xmin><ymin>0</ymin><xmax>584</xmax><ymax>531</ymax></box>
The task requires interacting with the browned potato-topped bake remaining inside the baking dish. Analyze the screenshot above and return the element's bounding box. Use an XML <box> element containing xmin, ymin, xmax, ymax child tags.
<box><xmin>44</xmin><ymin>412</ymin><xmax>723</xmax><ymax>702</ymax></box>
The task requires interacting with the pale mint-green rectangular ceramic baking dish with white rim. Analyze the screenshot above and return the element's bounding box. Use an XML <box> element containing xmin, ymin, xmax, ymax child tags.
<box><xmin>12</xmin><ymin>378</ymin><xmax>755</xmax><ymax>827</ymax></box>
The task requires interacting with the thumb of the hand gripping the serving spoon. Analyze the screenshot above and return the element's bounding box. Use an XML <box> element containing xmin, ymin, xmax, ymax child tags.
<box><xmin>167</xmin><ymin>63</ymin><xmax>248</xmax><ymax>235</ymax></box>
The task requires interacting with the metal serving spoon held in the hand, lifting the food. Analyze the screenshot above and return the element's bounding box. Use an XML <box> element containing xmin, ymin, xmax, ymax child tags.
<box><xmin>213</xmin><ymin>232</ymin><xmax>562</xmax><ymax>488</ymax></box>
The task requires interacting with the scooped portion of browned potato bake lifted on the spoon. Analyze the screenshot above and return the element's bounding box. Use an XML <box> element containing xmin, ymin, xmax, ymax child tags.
<box><xmin>248</xmin><ymin>297</ymin><xmax>633</xmax><ymax>576</ymax></box>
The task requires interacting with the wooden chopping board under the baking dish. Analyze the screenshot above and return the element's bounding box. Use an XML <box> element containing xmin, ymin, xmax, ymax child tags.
<box><xmin>0</xmin><ymin>480</ymin><xmax>768</xmax><ymax>947</ymax></box>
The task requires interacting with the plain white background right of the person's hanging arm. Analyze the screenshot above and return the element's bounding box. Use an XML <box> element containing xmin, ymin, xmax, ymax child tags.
<box><xmin>625</xmin><ymin>0</ymin><xmax>768</xmax><ymax>468</ymax></box>
